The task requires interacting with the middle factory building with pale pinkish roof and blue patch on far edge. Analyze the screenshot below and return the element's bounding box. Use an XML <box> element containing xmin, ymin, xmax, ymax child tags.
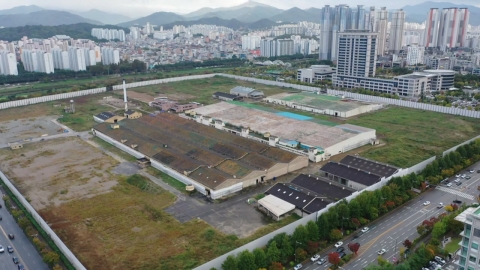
<box><xmin>189</xmin><ymin>102</ymin><xmax>376</xmax><ymax>162</ymax></box>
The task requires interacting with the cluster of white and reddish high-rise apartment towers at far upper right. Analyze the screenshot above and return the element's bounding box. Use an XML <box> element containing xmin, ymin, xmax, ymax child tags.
<box><xmin>423</xmin><ymin>8</ymin><xmax>470</xmax><ymax>50</ymax></box>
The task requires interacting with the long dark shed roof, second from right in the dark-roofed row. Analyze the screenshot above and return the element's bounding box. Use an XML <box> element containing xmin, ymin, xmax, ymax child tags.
<box><xmin>320</xmin><ymin>162</ymin><xmax>380</xmax><ymax>186</ymax></box>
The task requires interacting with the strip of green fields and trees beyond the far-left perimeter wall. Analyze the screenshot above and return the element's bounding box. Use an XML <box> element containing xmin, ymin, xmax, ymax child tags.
<box><xmin>0</xmin><ymin>68</ymin><xmax>231</xmax><ymax>100</ymax></box>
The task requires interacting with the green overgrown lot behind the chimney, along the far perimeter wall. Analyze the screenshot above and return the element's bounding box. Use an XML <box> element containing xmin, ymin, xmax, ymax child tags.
<box><xmin>116</xmin><ymin>76</ymin><xmax>293</xmax><ymax>104</ymax></box>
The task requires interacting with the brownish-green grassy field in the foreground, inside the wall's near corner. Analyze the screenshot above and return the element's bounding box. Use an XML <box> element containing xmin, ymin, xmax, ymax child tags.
<box><xmin>40</xmin><ymin>176</ymin><xmax>298</xmax><ymax>269</ymax></box>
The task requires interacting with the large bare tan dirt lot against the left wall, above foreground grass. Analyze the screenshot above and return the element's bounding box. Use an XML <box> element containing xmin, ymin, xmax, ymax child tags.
<box><xmin>0</xmin><ymin>138</ymin><xmax>118</xmax><ymax>210</ymax></box>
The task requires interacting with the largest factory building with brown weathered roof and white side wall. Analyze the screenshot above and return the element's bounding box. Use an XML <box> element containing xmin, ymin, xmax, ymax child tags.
<box><xmin>94</xmin><ymin>113</ymin><xmax>308</xmax><ymax>197</ymax></box>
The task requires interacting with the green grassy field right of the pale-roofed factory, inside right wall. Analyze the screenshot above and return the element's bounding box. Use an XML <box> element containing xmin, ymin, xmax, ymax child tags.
<box><xmin>346</xmin><ymin>107</ymin><xmax>480</xmax><ymax>168</ymax></box>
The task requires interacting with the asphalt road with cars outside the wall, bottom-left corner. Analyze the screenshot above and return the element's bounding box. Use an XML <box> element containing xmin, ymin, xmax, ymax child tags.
<box><xmin>0</xmin><ymin>199</ymin><xmax>49</xmax><ymax>270</ymax></box>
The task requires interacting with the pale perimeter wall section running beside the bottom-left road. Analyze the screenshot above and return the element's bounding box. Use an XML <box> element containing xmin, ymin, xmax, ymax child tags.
<box><xmin>0</xmin><ymin>171</ymin><xmax>87</xmax><ymax>270</ymax></box>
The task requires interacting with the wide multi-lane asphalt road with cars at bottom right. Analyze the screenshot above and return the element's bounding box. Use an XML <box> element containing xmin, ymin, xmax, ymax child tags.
<box><xmin>302</xmin><ymin>163</ymin><xmax>480</xmax><ymax>270</ymax></box>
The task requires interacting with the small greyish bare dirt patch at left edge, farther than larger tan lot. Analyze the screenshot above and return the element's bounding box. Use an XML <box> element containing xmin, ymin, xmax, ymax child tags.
<box><xmin>0</xmin><ymin>116</ymin><xmax>67</xmax><ymax>144</ymax></box>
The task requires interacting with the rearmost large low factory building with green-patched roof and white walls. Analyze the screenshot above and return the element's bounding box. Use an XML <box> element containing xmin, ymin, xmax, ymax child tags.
<box><xmin>264</xmin><ymin>92</ymin><xmax>382</xmax><ymax>117</ymax></box>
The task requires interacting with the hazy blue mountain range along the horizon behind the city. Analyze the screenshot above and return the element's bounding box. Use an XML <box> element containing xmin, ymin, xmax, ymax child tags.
<box><xmin>0</xmin><ymin>0</ymin><xmax>480</xmax><ymax>29</ymax></box>
